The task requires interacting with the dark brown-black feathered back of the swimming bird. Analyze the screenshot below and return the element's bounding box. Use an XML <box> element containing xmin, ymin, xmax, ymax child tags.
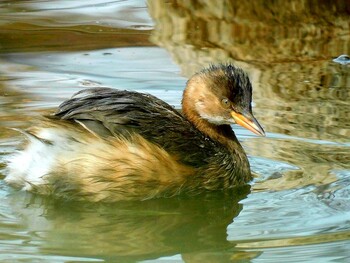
<box><xmin>55</xmin><ymin>88</ymin><xmax>218</xmax><ymax>167</ymax></box>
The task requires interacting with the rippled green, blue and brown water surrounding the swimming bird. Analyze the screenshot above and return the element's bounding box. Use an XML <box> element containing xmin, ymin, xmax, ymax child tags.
<box><xmin>0</xmin><ymin>0</ymin><xmax>350</xmax><ymax>262</ymax></box>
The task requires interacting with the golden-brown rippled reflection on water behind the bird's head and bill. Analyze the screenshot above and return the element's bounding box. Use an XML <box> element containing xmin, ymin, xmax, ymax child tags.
<box><xmin>149</xmin><ymin>0</ymin><xmax>350</xmax><ymax>144</ymax></box>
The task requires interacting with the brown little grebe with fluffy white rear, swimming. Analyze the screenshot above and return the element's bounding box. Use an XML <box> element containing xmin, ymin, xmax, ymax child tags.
<box><xmin>5</xmin><ymin>64</ymin><xmax>265</xmax><ymax>202</ymax></box>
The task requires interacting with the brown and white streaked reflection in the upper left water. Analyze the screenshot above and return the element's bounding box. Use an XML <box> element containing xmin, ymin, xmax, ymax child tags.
<box><xmin>0</xmin><ymin>0</ymin><xmax>154</xmax><ymax>53</ymax></box>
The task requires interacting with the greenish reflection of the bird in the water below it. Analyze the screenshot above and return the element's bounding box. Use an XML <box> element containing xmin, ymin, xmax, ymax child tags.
<box><xmin>6</xmin><ymin>185</ymin><xmax>257</xmax><ymax>262</ymax></box>
